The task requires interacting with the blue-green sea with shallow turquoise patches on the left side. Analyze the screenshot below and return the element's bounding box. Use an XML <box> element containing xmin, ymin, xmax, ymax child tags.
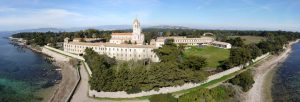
<box><xmin>0</xmin><ymin>35</ymin><xmax>61</xmax><ymax>102</ymax></box>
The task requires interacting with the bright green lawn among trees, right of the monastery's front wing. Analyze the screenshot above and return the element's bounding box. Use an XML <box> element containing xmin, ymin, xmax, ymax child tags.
<box><xmin>184</xmin><ymin>46</ymin><xmax>230</xmax><ymax>68</ymax></box>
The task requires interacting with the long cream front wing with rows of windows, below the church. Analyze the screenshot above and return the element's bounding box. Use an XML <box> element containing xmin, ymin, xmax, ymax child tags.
<box><xmin>64</xmin><ymin>38</ymin><xmax>159</xmax><ymax>62</ymax></box>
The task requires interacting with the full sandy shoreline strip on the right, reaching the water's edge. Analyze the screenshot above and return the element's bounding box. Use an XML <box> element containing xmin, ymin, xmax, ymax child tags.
<box><xmin>245</xmin><ymin>39</ymin><xmax>299</xmax><ymax>102</ymax></box>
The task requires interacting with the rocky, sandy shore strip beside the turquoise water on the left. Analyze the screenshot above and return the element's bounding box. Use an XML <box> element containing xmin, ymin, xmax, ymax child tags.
<box><xmin>9</xmin><ymin>38</ymin><xmax>78</xmax><ymax>102</ymax></box>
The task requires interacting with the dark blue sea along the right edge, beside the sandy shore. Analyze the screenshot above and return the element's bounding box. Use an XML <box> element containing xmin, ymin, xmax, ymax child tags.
<box><xmin>272</xmin><ymin>43</ymin><xmax>300</xmax><ymax>102</ymax></box>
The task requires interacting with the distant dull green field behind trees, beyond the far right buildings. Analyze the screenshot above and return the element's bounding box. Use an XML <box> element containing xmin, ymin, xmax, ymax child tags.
<box><xmin>229</xmin><ymin>36</ymin><xmax>266</xmax><ymax>44</ymax></box>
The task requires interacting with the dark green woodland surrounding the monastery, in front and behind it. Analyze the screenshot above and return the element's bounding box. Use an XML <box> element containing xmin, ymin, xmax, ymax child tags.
<box><xmin>13</xmin><ymin>29</ymin><xmax>300</xmax><ymax>93</ymax></box>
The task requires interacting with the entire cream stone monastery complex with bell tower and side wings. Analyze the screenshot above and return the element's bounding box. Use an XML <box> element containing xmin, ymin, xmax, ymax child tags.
<box><xmin>63</xmin><ymin>19</ymin><xmax>231</xmax><ymax>62</ymax></box>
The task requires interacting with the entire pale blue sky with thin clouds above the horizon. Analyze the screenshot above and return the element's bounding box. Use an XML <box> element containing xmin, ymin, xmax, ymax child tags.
<box><xmin>0</xmin><ymin>0</ymin><xmax>300</xmax><ymax>31</ymax></box>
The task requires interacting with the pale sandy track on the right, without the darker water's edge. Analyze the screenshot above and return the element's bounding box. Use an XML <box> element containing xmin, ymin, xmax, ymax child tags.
<box><xmin>245</xmin><ymin>42</ymin><xmax>295</xmax><ymax>102</ymax></box>
